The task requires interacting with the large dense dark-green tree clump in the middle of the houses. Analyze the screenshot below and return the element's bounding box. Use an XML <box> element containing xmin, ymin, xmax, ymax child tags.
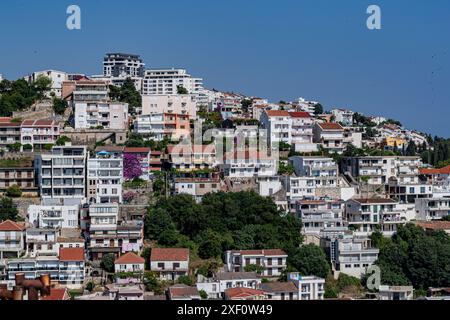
<box><xmin>146</xmin><ymin>192</ymin><xmax>302</xmax><ymax>259</ymax></box>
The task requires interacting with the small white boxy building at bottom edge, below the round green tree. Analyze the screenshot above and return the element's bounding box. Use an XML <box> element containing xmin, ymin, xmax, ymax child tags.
<box><xmin>288</xmin><ymin>272</ymin><xmax>325</xmax><ymax>300</ymax></box>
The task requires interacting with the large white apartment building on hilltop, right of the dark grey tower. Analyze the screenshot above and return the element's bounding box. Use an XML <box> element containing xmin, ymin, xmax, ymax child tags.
<box><xmin>142</xmin><ymin>68</ymin><xmax>203</xmax><ymax>96</ymax></box>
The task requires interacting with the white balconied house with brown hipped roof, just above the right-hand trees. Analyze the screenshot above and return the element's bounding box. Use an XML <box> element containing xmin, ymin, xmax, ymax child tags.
<box><xmin>345</xmin><ymin>198</ymin><xmax>406</xmax><ymax>236</ymax></box>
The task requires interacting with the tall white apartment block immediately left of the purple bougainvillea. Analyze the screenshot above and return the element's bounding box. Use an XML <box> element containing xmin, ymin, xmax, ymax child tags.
<box><xmin>87</xmin><ymin>147</ymin><xmax>123</xmax><ymax>203</ymax></box>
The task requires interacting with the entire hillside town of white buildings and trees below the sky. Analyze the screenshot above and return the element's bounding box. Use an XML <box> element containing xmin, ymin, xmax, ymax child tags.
<box><xmin>0</xmin><ymin>53</ymin><xmax>450</xmax><ymax>300</ymax></box>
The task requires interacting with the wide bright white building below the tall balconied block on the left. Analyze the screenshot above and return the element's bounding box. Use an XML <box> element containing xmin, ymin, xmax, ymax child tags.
<box><xmin>27</xmin><ymin>205</ymin><xmax>80</xmax><ymax>229</ymax></box>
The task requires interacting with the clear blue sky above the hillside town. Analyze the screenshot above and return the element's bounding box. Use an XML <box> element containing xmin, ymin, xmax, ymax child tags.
<box><xmin>0</xmin><ymin>0</ymin><xmax>450</xmax><ymax>137</ymax></box>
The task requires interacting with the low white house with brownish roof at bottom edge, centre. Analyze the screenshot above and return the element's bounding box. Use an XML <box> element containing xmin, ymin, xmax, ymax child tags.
<box><xmin>197</xmin><ymin>272</ymin><xmax>261</xmax><ymax>299</ymax></box>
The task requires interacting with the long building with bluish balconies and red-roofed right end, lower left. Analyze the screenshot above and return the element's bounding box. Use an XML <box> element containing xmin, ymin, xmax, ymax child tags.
<box><xmin>6</xmin><ymin>248</ymin><xmax>85</xmax><ymax>289</ymax></box>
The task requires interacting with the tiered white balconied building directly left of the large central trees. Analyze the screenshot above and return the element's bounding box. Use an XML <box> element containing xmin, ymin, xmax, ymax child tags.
<box><xmin>88</xmin><ymin>204</ymin><xmax>144</xmax><ymax>261</ymax></box>
